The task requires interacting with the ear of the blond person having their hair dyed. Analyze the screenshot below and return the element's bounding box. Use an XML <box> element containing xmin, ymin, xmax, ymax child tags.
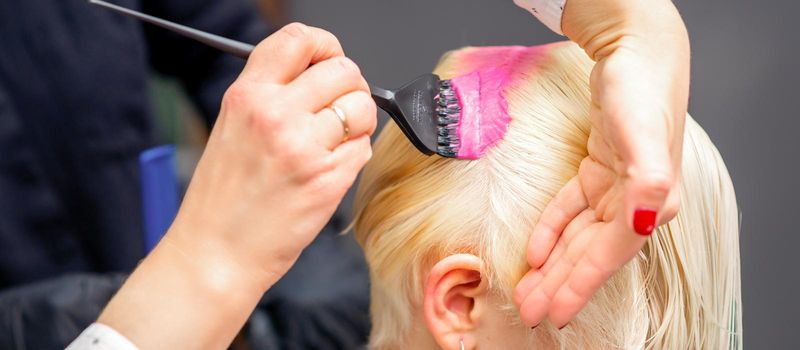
<box><xmin>423</xmin><ymin>254</ymin><xmax>488</xmax><ymax>350</ymax></box>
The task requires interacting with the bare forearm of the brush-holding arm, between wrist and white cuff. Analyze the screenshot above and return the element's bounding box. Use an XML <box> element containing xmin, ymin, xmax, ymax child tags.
<box><xmin>98</xmin><ymin>228</ymin><xmax>278</xmax><ymax>349</ymax></box>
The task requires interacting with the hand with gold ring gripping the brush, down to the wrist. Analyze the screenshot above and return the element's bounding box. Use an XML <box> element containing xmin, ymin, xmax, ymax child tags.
<box><xmin>169</xmin><ymin>24</ymin><xmax>377</xmax><ymax>280</ymax></box>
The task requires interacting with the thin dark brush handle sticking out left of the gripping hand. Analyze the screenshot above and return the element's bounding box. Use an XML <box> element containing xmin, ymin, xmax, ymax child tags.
<box><xmin>89</xmin><ymin>0</ymin><xmax>254</xmax><ymax>59</ymax></box>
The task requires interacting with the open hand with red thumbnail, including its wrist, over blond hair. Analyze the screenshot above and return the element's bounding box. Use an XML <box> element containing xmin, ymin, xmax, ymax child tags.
<box><xmin>515</xmin><ymin>0</ymin><xmax>689</xmax><ymax>327</ymax></box>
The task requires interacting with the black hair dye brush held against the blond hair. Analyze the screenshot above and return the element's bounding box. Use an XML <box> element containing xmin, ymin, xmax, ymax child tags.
<box><xmin>89</xmin><ymin>0</ymin><xmax>461</xmax><ymax>158</ymax></box>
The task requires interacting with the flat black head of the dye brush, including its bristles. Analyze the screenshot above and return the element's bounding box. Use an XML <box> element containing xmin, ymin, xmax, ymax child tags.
<box><xmin>376</xmin><ymin>74</ymin><xmax>461</xmax><ymax>158</ymax></box>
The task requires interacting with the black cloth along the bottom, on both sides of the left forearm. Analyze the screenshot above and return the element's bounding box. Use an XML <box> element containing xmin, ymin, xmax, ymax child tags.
<box><xmin>0</xmin><ymin>220</ymin><xmax>369</xmax><ymax>350</ymax></box>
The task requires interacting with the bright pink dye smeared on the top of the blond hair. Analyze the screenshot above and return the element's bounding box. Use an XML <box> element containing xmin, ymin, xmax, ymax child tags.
<box><xmin>451</xmin><ymin>45</ymin><xmax>549</xmax><ymax>159</ymax></box>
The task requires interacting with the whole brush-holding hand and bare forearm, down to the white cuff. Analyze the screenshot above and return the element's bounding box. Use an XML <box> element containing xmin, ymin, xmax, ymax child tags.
<box><xmin>98</xmin><ymin>24</ymin><xmax>376</xmax><ymax>349</ymax></box>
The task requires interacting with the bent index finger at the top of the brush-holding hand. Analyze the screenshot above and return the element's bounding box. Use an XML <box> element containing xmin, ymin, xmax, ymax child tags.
<box><xmin>241</xmin><ymin>23</ymin><xmax>344</xmax><ymax>84</ymax></box>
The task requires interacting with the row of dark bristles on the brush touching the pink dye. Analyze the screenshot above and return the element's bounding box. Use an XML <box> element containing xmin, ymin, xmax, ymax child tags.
<box><xmin>436</xmin><ymin>80</ymin><xmax>461</xmax><ymax>158</ymax></box>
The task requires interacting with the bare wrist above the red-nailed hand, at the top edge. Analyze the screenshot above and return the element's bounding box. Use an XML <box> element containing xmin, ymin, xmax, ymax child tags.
<box><xmin>561</xmin><ymin>0</ymin><xmax>689</xmax><ymax>61</ymax></box>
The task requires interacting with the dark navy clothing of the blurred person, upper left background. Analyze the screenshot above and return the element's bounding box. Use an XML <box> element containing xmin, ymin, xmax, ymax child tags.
<box><xmin>0</xmin><ymin>0</ymin><xmax>268</xmax><ymax>288</ymax></box>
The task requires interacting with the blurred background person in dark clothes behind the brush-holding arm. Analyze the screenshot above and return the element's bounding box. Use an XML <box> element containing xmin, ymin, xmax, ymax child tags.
<box><xmin>0</xmin><ymin>0</ymin><xmax>368</xmax><ymax>349</ymax></box>
